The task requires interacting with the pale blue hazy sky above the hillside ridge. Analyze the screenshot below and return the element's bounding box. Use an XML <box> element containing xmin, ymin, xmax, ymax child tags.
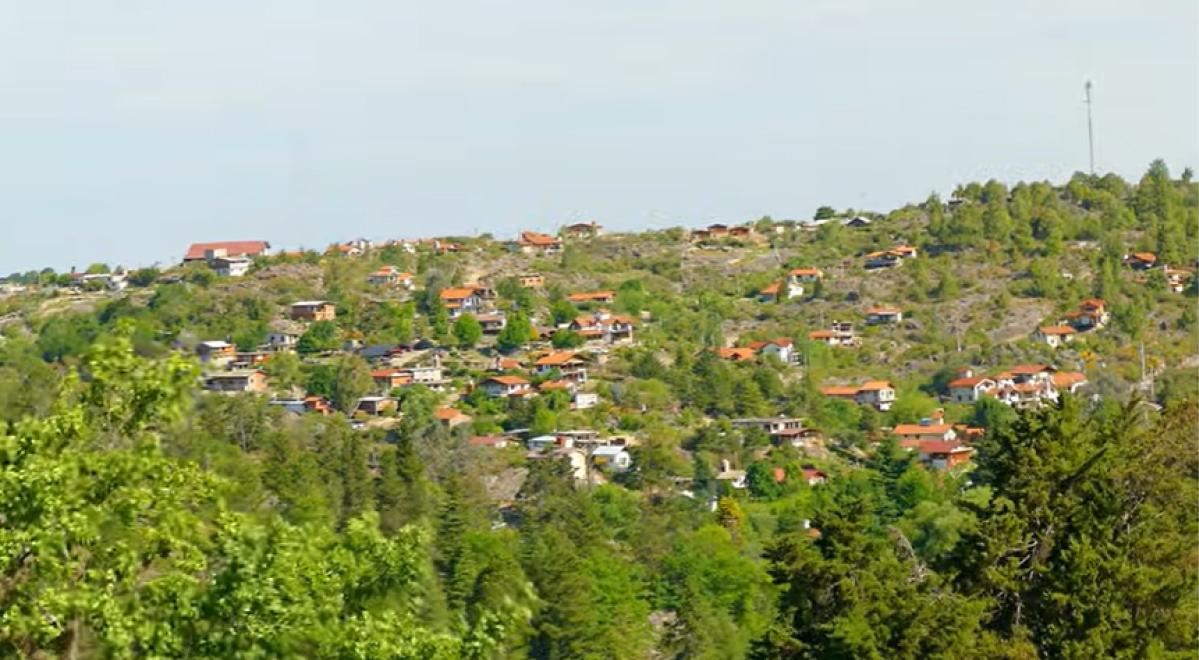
<box><xmin>0</xmin><ymin>0</ymin><xmax>1199</xmax><ymax>274</ymax></box>
